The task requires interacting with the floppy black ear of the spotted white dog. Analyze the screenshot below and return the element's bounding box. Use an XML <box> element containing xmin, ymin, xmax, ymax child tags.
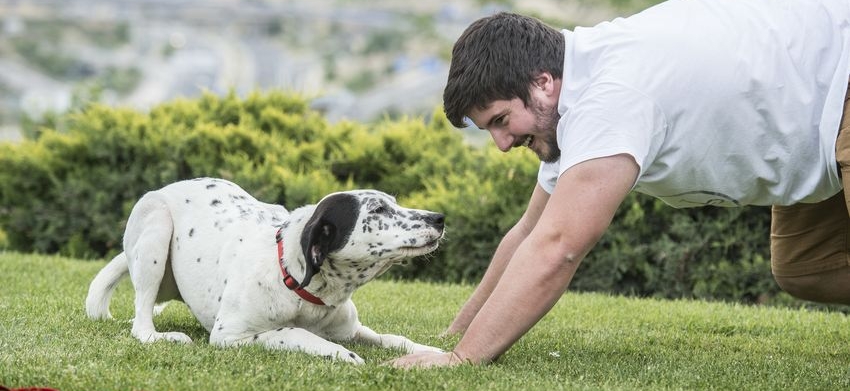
<box><xmin>301</xmin><ymin>193</ymin><xmax>360</xmax><ymax>288</ymax></box>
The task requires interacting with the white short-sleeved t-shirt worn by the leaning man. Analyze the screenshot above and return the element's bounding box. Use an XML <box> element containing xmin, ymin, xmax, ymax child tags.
<box><xmin>538</xmin><ymin>0</ymin><xmax>850</xmax><ymax>207</ymax></box>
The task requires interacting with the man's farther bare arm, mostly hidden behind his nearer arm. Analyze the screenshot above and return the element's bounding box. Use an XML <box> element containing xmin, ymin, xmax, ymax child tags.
<box><xmin>445</xmin><ymin>184</ymin><xmax>549</xmax><ymax>334</ymax></box>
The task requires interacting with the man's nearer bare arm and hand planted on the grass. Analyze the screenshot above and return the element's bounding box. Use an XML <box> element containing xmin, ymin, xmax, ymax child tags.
<box><xmin>393</xmin><ymin>155</ymin><xmax>638</xmax><ymax>368</ymax></box>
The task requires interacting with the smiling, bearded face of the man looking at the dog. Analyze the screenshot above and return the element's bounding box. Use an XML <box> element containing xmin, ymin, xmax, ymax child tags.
<box><xmin>460</xmin><ymin>94</ymin><xmax>561</xmax><ymax>163</ymax></box>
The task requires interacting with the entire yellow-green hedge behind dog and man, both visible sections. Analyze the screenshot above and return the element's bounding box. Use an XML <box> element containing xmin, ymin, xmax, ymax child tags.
<box><xmin>0</xmin><ymin>92</ymin><xmax>778</xmax><ymax>303</ymax></box>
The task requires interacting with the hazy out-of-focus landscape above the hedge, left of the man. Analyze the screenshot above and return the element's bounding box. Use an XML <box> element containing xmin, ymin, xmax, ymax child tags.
<box><xmin>0</xmin><ymin>0</ymin><xmax>651</xmax><ymax>140</ymax></box>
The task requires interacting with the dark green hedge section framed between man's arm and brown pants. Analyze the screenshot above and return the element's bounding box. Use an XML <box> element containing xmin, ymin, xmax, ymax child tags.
<box><xmin>574</xmin><ymin>194</ymin><xmax>779</xmax><ymax>303</ymax></box>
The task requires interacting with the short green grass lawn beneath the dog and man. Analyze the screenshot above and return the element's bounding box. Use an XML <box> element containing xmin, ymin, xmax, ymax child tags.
<box><xmin>0</xmin><ymin>253</ymin><xmax>850</xmax><ymax>391</ymax></box>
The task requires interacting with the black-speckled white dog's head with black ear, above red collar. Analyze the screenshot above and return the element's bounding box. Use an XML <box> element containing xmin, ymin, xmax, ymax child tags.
<box><xmin>301</xmin><ymin>190</ymin><xmax>444</xmax><ymax>287</ymax></box>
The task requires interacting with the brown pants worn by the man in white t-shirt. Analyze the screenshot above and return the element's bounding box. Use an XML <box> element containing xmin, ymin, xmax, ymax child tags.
<box><xmin>770</xmin><ymin>84</ymin><xmax>850</xmax><ymax>292</ymax></box>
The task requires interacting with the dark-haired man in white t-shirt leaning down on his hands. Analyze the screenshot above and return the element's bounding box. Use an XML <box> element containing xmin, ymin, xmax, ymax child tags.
<box><xmin>392</xmin><ymin>0</ymin><xmax>850</xmax><ymax>368</ymax></box>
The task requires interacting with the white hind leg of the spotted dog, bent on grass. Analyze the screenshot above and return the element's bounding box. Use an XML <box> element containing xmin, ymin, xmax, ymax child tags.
<box><xmin>124</xmin><ymin>192</ymin><xmax>192</xmax><ymax>342</ymax></box>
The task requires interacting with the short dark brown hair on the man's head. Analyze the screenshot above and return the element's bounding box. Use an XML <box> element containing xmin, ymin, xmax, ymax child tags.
<box><xmin>443</xmin><ymin>12</ymin><xmax>564</xmax><ymax>128</ymax></box>
